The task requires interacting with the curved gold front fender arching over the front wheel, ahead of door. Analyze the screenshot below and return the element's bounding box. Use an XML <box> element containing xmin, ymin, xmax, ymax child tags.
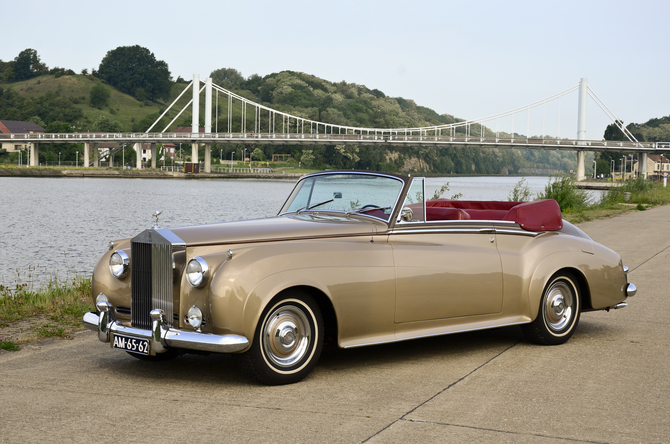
<box><xmin>209</xmin><ymin>237</ymin><xmax>395</xmax><ymax>348</ymax></box>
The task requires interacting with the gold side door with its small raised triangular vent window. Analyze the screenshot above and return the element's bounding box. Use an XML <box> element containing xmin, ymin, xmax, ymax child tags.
<box><xmin>388</xmin><ymin>178</ymin><xmax>503</xmax><ymax>323</ymax></box>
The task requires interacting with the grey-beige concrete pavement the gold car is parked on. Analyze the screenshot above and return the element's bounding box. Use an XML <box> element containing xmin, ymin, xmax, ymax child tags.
<box><xmin>0</xmin><ymin>206</ymin><xmax>670</xmax><ymax>443</ymax></box>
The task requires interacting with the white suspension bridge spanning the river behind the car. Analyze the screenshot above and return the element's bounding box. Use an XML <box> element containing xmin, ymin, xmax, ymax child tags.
<box><xmin>0</xmin><ymin>74</ymin><xmax>670</xmax><ymax>180</ymax></box>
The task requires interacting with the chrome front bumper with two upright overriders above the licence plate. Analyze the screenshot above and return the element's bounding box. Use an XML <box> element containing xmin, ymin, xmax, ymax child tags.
<box><xmin>83</xmin><ymin>302</ymin><xmax>249</xmax><ymax>355</ymax></box>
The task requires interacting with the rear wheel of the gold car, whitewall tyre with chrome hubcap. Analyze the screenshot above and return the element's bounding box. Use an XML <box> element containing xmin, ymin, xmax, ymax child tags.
<box><xmin>521</xmin><ymin>273</ymin><xmax>581</xmax><ymax>345</ymax></box>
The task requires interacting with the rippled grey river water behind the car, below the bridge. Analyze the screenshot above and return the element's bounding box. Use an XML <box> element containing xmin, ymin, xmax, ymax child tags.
<box><xmin>0</xmin><ymin>176</ymin><xmax>600</xmax><ymax>286</ymax></box>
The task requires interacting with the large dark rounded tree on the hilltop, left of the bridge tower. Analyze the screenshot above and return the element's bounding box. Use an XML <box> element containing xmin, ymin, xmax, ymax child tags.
<box><xmin>97</xmin><ymin>45</ymin><xmax>172</xmax><ymax>100</ymax></box>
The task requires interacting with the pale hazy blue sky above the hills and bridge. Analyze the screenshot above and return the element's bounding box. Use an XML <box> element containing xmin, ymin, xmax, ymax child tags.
<box><xmin>0</xmin><ymin>0</ymin><xmax>670</xmax><ymax>140</ymax></box>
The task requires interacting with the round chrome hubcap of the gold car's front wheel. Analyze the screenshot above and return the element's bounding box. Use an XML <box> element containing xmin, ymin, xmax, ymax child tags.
<box><xmin>263</xmin><ymin>305</ymin><xmax>312</xmax><ymax>367</ymax></box>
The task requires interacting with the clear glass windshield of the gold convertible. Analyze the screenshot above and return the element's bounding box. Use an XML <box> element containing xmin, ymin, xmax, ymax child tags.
<box><xmin>279</xmin><ymin>173</ymin><xmax>403</xmax><ymax>221</ymax></box>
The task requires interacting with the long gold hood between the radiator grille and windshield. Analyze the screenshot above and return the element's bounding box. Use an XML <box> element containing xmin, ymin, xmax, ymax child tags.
<box><xmin>163</xmin><ymin>213</ymin><xmax>386</xmax><ymax>246</ymax></box>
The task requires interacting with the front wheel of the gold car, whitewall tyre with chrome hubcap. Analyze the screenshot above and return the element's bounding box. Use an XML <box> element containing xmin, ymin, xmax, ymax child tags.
<box><xmin>243</xmin><ymin>293</ymin><xmax>324</xmax><ymax>385</ymax></box>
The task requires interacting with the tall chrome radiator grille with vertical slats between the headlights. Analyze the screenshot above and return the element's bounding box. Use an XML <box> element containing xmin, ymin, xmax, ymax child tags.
<box><xmin>130</xmin><ymin>230</ymin><xmax>174</xmax><ymax>330</ymax></box>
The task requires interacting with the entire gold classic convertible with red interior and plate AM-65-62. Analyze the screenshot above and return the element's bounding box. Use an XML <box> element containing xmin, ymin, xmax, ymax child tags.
<box><xmin>83</xmin><ymin>171</ymin><xmax>636</xmax><ymax>384</ymax></box>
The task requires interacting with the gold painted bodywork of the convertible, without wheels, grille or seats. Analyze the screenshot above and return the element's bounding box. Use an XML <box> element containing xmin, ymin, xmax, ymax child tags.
<box><xmin>86</xmin><ymin>172</ymin><xmax>627</xmax><ymax>352</ymax></box>
